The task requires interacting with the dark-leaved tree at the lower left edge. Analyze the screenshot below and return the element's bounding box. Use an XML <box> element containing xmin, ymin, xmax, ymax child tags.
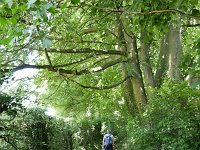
<box><xmin>0</xmin><ymin>73</ymin><xmax>24</xmax><ymax>149</ymax></box>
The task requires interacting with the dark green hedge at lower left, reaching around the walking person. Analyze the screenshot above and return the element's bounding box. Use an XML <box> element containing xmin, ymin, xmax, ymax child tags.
<box><xmin>0</xmin><ymin>108</ymin><xmax>126</xmax><ymax>150</ymax></box>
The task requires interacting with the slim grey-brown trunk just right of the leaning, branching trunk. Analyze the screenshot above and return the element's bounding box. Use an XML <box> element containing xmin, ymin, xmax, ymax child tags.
<box><xmin>141</xmin><ymin>30</ymin><xmax>155</xmax><ymax>87</ymax></box>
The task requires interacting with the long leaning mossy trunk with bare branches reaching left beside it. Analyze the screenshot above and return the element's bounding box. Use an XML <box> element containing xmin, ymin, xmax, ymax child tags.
<box><xmin>120</xmin><ymin>16</ymin><xmax>147</xmax><ymax>112</ymax></box>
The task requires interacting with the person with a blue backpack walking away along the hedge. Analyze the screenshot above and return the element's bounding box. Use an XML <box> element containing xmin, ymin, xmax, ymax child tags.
<box><xmin>102</xmin><ymin>130</ymin><xmax>114</xmax><ymax>150</ymax></box>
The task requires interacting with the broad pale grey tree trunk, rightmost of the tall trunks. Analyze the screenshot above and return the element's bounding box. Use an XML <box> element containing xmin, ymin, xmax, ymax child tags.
<box><xmin>168</xmin><ymin>25</ymin><xmax>182</xmax><ymax>80</ymax></box>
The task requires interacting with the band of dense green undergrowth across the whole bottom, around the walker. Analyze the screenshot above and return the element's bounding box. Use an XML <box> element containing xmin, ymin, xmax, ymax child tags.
<box><xmin>1</xmin><ymin>82</ymin><xmax>200</xmax><ymax>150</ymax></box>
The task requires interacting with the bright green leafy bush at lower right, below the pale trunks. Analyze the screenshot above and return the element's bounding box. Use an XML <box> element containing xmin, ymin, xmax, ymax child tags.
<box><xmin>128</xmin><ymin>83</ymin><xmax>200</xmax><ymax>150</ymax></box>
